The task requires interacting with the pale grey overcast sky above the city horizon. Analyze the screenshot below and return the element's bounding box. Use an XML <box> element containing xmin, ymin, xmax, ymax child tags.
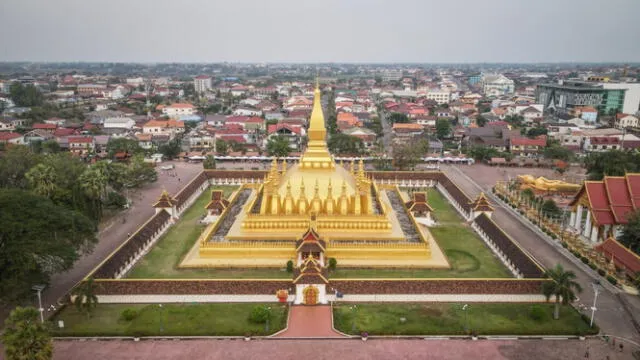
<box><xmin>0</xmin><ymin>0</ymin><xmax>640</xmax><ymax>62</ymax></box>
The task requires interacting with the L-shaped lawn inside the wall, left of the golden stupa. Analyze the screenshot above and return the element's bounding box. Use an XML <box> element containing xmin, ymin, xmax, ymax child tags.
<box><xmin>127</xmin><ymin>186</ymin><xmax>291</xmax><ymax>279</ymax></box>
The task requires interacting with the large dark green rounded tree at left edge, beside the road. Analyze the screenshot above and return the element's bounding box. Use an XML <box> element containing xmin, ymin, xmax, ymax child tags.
<box><xmin>0</xmin><ymin>189</ymin><xmax>96</xmax><ymax>302</ymax></box>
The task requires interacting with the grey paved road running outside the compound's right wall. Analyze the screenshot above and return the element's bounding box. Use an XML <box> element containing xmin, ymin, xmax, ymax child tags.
<box><xmin>441</xmin><ymin>165</ymin><xmax>640</xmax><ymax>341</ymax></box>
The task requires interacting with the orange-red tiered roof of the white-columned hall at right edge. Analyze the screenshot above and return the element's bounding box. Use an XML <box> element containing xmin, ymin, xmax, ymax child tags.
<box><xmin>569</xmin><ymin>173</ymin><xmax>640</xmax><ymax>225</ymax></box>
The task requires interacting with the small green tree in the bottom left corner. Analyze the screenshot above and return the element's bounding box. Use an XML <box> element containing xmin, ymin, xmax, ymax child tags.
<box><xmin>2</xmin><ymin>307</ymin><xmax>53</xmax><ymax>360</ymax></box>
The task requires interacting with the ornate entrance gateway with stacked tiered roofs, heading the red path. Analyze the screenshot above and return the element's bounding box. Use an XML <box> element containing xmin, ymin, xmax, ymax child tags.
<box><xmin>293</xmin><ymin>227</ymin><xmax>329</xmax><ymax>305</ymax></box>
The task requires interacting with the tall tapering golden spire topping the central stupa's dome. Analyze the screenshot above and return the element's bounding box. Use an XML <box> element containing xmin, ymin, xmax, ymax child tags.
<box><xmin>300</xmin><ymin>79</ymin><xmax>335</xmax><ymax>169</ymax></box>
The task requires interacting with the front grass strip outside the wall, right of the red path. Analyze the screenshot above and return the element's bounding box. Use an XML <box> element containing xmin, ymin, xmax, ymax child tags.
<box><xmin>333</xmin><ymin>303</ymin><xmax>597</xmax><ymax>335</ymax></box>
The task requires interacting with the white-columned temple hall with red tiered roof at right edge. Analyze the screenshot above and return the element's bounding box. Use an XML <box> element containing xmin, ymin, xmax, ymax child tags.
<box><xmin>569</xmin><ymin>173</ymin><xmax>640</xmax><ymax>242</ymax></box>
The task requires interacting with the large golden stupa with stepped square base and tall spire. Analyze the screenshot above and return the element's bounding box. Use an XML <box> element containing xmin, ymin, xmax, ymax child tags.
<box><xmin>180</xmin><ymin>81</ymin><xmax>449</xmax><ymax>267</ymax></box>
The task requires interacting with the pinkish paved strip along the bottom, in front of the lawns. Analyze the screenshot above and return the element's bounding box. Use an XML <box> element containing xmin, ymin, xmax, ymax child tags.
<box><xmin>0</xmin><ymin>339</ymin><xmax>633</xmax><ymax>360</ymax></box>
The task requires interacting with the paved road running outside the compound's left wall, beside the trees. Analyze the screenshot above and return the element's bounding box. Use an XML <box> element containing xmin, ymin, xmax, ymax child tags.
<box><xmin>34</xmin><ymin>162</ymin><xmax>202</xmax><ymax>315</ymax></box>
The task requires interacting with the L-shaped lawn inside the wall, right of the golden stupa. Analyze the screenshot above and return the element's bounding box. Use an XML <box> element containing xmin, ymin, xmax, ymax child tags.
<box><xmin>331</xmin><ymin>189</ymin><xmax>512</xmax><ymax>278</ymax></box>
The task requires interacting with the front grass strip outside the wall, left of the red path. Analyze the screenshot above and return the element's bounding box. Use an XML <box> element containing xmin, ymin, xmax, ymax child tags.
<box><xmin>53</xmin><ymin>303</ymin><xmax>287</xmax><ymax>336</ymax></box>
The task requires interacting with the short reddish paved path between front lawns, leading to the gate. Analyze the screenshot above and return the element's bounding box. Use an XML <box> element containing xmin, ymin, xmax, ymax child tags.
<box><xmin>276</xmin><ymin>305</ymin><xmax>342</xmax><ymax>338</ymax></box>
